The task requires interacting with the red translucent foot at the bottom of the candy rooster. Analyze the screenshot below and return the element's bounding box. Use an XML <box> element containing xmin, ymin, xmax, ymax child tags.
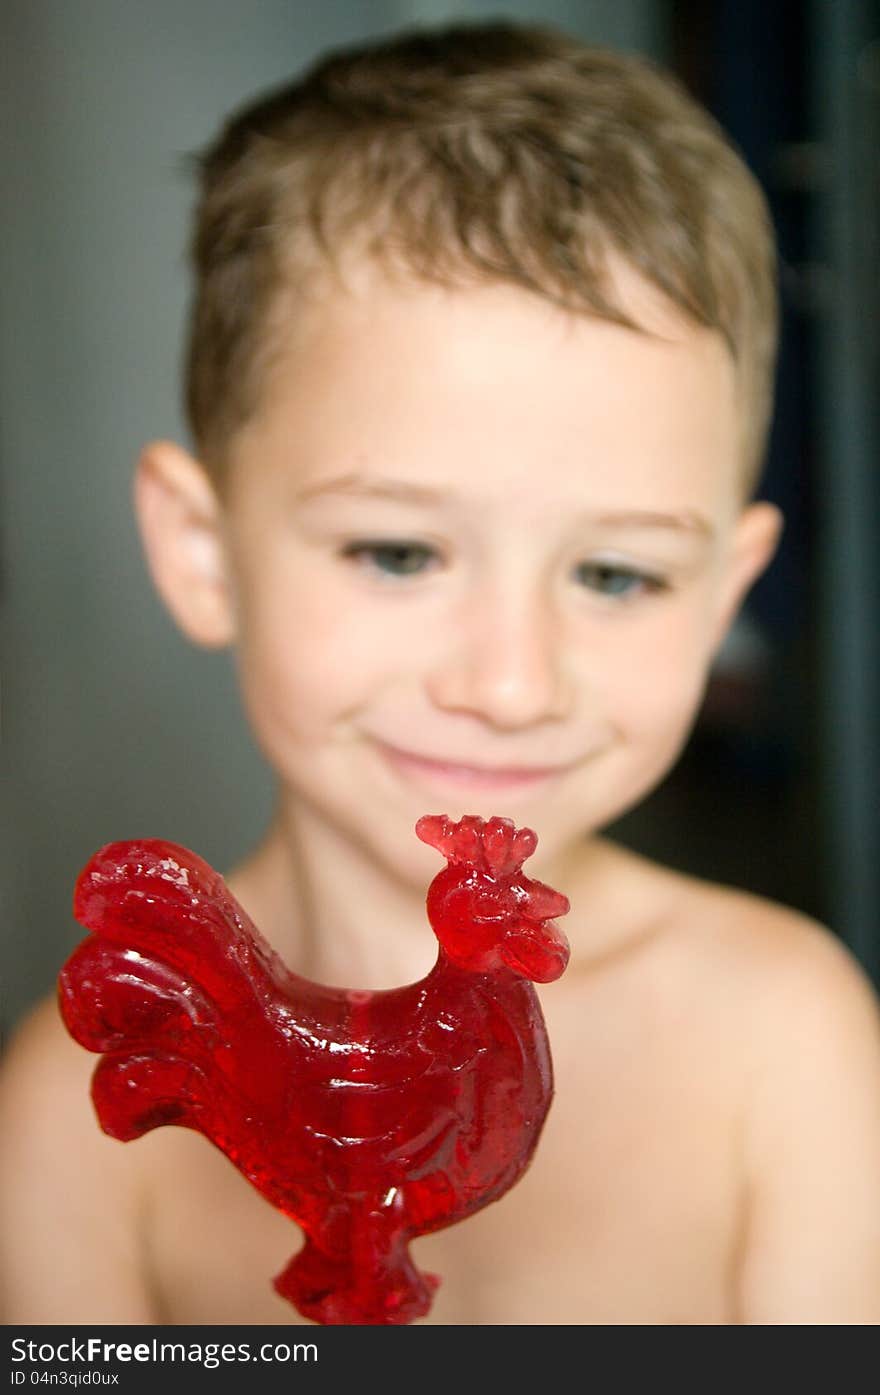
<box><xmin>275</xmin><ymin>1187</ymin><xmax>439</xmax><ymax>1325</ymax></box>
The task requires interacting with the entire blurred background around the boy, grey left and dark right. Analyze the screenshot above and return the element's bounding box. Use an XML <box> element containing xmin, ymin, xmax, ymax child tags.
<box><xmin>0</xmin><ymin>0</ymin><xmax>880</xmax><ymax>1031</ymax></box>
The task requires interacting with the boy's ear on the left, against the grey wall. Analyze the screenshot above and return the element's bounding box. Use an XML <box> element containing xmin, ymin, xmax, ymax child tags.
<box><xmin>134</xmin><ymin>441</ymin><xmax>234</xmax><ymax>649</ymax></box>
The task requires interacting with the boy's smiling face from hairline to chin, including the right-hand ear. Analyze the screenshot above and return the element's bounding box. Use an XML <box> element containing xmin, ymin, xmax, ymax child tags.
<box><xmin>149</xmin><ymin>259</ymin><xmax>780</xmax><ymax>884</ymax></box>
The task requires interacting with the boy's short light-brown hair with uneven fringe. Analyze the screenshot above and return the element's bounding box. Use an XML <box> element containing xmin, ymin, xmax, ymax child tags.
<box><xmin>187</xmin><ymin>22</ymin><xmax>777</xmax><ymax>495</ymax></box>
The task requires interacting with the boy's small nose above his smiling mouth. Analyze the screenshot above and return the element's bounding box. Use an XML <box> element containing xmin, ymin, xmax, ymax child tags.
<box><xmin>428</xmin><ymin>580</ymin><xmax>573</xmax><ymax>730</ymax></box>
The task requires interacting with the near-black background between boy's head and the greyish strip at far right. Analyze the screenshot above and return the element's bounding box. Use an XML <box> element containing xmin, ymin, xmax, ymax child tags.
<box><xmin>605</xmin><ymin>0</ymin><xmax>830</xmax><ymax>898</ymax></box>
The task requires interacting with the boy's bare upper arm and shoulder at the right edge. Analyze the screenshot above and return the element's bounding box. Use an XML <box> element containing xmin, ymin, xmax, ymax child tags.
<box><xmin>647</xmin><ymin>848</ymin><xmax>880</xmax><ymax>1324</ymax></box>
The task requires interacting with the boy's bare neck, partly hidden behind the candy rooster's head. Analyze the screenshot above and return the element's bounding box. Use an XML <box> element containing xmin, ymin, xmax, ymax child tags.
<box><xmin>227</xmin><ymin>804</ymin><xmax>625</xmax><ymax>989</ymax></box>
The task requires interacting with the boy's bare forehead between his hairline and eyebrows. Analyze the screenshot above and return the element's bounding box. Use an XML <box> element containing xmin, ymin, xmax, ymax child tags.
<box><xmin>234</xmin><ymin>262</ymin><xmax>739</xmax><ymax>508</ymax></box>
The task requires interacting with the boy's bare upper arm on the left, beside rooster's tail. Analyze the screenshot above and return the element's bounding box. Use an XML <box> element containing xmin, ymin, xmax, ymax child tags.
<box><xmin>0</xmin><ymin>999</ymin><xmax>149</xmax><ymax>1322</ymax></box>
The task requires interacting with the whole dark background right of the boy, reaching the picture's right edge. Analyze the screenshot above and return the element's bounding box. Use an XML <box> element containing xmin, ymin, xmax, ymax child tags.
<box><xmin>612</xmin><ymin>0</ymin><xmax>880</xmax><ymax>975</ymax></box>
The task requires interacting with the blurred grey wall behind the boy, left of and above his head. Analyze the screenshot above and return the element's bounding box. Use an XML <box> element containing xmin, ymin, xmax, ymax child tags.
<box><xmin>0</xmin><ymin>0</ymin><xmax>661</xmax><ymax>1027</ymax></box>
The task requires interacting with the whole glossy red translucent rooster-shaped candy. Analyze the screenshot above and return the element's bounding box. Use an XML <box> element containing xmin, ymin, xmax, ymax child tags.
<box><xmin>59</xmin><ymin>815</ymin><xmax>569</xmax><ymax>1324</ymax></box>
